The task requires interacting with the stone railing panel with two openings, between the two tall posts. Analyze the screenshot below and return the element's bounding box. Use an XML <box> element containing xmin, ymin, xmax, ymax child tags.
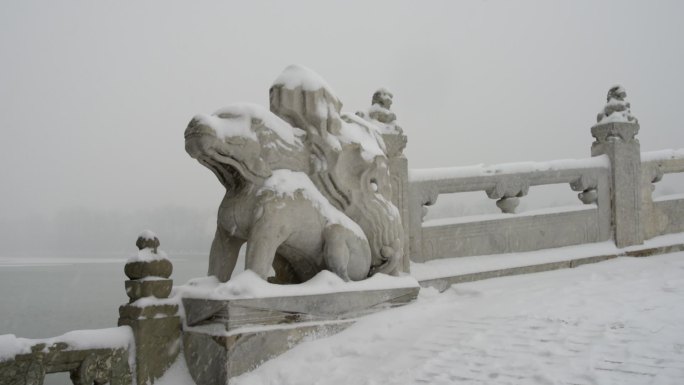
<box><xmin>409</xmin><ymin>156</ymin><xmax>611</xmax><ymax>262</ymax></box>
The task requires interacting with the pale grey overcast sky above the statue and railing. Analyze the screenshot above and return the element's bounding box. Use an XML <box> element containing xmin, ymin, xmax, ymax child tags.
<box><xmin>0</xmin><ymin>0</ymin><xmax>684</xmax><ymax>220</ymax></box>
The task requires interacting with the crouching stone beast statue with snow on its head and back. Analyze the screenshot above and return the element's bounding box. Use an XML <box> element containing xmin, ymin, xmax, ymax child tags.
<box><xmin>185</xmin><ymin>66</ymin><xmax>404</xmax><ymax>283</ymax></box>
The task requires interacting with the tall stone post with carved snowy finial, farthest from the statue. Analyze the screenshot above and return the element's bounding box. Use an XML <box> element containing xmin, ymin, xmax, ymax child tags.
<box><xmin>591</xmin><ymin>86</ymin><xmax>643</xmax><ymax>248</ymax></box>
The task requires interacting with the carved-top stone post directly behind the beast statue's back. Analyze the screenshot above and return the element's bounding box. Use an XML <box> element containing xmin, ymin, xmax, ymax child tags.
<box><xmin>357</xmin><ymin>88</ymin><xmax>410</xmax><ymax>273</ymax></box>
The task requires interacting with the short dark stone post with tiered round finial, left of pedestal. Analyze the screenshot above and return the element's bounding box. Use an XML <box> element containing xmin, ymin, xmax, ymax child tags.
<box><xmin>119</xmin><ymin>231</ymin><xmax>181</xmax><ymax>385</ymax></box>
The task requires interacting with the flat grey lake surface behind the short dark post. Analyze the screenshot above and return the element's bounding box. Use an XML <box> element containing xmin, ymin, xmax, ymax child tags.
<box><xmin>0</xmin><ymin>253</ymin><xmax>208</xmax><ymax>338</ymax></box>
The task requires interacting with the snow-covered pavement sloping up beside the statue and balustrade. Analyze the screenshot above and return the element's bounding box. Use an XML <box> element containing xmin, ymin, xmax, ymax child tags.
<box><xmin>231</xmin><ymin>253</ymin><xmax>684</xmax><ymax>385</ymax></box>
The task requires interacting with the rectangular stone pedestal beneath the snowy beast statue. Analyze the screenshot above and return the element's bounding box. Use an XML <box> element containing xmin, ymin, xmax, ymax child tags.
<box><xmin>183</xmin><ymin>286</ymin><xmax>419</xmax><ymax>385</ymax></box>
